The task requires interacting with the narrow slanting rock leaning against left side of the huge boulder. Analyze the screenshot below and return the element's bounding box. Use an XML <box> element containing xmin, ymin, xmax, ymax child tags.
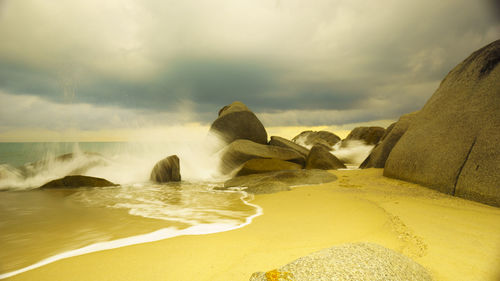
<box><xmin>359</xmin><ymin>112</ymin><xmax>417</xmax><ymax>169</ymax></box>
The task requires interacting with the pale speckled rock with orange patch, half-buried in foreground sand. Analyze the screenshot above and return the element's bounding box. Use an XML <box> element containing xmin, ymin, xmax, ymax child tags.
<box><xmin>250</xmin><ymin>243</ymin><xmax>432</xmax><ymax>281</ymax></box>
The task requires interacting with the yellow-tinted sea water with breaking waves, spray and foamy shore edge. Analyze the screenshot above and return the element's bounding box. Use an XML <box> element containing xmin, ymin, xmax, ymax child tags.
<box><xmin>0</xmin><ymin>139</ymin><xmax>261</xmax><ymax>279</ymax></box>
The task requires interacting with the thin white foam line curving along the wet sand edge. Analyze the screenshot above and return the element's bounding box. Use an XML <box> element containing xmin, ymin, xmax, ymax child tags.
<box><xmin>0</xmin><ymin>191</ymin><xmax>264</xmax><ymax>279</ymax></box>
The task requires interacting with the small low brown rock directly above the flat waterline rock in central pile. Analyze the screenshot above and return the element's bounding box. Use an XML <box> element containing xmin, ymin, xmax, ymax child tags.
<box><xmin>236</xmin><ymin>158</ymin><xmax>302</xmax><ymax>176</ymax></box>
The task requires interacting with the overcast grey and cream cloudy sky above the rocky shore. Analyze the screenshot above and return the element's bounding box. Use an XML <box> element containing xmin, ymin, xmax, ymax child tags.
<box><xmin>0</xmin><ymin>0</ymin><xmax>500</xmax><ymax>140</ymax></box>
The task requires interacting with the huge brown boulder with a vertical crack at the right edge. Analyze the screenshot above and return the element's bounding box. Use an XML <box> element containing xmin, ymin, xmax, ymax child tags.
<box><xmin>384</xmin><ymin>40</ymin><xmax>500</xmax><ymax>206</ymax></box>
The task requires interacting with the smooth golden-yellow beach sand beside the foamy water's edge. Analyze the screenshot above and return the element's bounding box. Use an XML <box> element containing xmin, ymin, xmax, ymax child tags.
<box><xmin>4</xmin><ymin>169</ymin><xmax>500</xmax><ymax>281</ymax></box>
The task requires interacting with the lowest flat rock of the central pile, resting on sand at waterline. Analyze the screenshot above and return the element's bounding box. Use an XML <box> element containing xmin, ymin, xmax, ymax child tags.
<box><xmin>224</xmin><ymin>170</ymin><xmax>337</xmax><ymax>193</ymax></box>
